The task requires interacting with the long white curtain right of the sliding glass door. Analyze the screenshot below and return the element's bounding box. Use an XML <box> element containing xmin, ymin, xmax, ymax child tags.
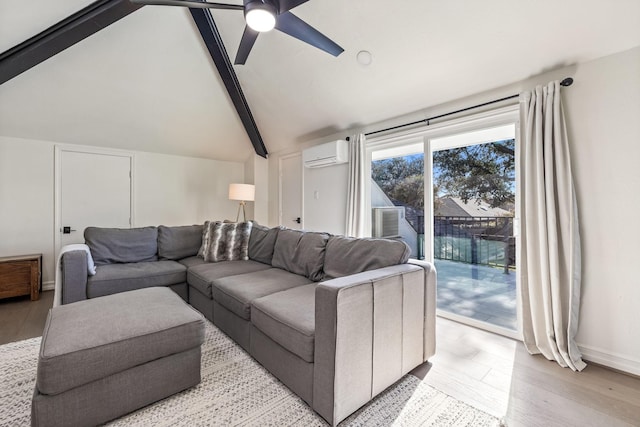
<box><xmin>520</xmin><ymin>81</ymin><xmax>586</xmax><ymax>371</ymax></box>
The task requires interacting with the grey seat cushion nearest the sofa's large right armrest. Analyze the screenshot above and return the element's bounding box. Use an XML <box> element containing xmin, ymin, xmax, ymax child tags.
<box><xmin>251</xmin><ymin>283</ymin><xmax>316</xmax><ymax>363</ymax></box>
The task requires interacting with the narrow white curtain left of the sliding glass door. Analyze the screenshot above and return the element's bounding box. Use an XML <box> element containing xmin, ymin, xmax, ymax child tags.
<box><xmin>345</xmin><ymin>133</ymin><xmax>366</xmax><ymax>237</ymax></box>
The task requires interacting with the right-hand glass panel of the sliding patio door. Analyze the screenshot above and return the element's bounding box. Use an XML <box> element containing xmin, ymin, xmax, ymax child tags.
<box><xmin>429</xmin><ymin>124</ymin><xmax>518</xmax><ymax>335</ymax></box>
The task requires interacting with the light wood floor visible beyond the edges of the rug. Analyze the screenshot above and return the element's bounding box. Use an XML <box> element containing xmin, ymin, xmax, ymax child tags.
<box><xmin>0</xmin><ymin>292</ymin><xmax>640</xmax><ymax>427</ymax></box>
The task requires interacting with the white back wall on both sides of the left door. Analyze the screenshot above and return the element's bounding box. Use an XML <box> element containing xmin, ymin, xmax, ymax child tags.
<box><xmin>0</xmin><ymin>136</ymin><xmax>244</xmax><ymax>284</ymax></box>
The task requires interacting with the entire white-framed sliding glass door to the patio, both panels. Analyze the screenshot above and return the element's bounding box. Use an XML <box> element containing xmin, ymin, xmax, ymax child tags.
<box><xmin>367</xmin><ymin>106</ymin><xmax>520</xmax><ymax>338</ymax></box>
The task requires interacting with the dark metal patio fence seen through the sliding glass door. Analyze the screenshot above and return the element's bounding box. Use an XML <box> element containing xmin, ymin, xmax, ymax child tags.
<box><xmin>434</xmin><ymin>216</ymin><xmax>516</xmax><ymax>273</ymax></box>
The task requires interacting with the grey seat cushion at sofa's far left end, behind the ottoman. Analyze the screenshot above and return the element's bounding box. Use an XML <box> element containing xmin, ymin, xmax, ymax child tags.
<box><xmin>87</xmin><ymin>261</ymin><xmax>187</xmax><ymax>298</ymax></box>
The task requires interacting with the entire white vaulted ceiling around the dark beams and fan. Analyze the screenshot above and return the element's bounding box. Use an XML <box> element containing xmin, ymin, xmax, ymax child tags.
<box><xmin>0</xmin><ymin>0</ymin><xmax>640</xmax><ymax>161</ymax></box>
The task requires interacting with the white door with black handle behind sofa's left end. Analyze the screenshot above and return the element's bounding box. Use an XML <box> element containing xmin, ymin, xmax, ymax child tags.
<box><xmin>57</xmin><ymin>149</ymin><xmax>132</xmax><ymax>250</ymax></box>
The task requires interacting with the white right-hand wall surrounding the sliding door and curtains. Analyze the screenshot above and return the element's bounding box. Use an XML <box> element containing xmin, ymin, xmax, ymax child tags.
<box><xmin>270</xmin><ymin>47</ymin><xmax>640</xmax><ymax>375</ymax></box>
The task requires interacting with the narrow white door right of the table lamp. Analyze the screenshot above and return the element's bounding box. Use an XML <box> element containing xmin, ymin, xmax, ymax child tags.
<box><xmin>280</xmin><ymin>154</ymin><xmax>303</xmax><ymax>229</ymax></box>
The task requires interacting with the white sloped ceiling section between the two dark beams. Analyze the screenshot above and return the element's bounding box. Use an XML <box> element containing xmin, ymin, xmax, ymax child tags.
<box><xmin>0</xmin><ymin>0</ymin><xmax>253</xmax><ymax>161</ymax></box>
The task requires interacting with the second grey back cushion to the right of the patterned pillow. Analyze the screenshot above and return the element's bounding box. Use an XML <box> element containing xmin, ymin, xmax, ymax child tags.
<box><xmin>271</xmin><ymin>228</ymin><xmax>329</xmax><ymax>281</ymax></box>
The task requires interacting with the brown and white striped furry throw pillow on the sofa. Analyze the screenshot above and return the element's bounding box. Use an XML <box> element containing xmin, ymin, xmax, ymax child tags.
<box><xmin>203</xmin><ymin>221</ymin><xmax>252</xmax><ymax>262</ymax></box>
